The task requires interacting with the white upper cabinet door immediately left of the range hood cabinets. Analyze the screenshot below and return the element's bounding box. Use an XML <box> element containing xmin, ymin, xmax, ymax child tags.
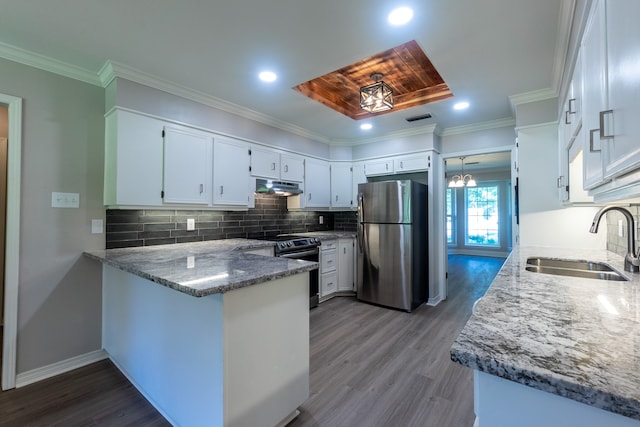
<box><xmin>213</xmin><ymin>136</ymin><xmax>249</xmax><ymax>206</ymax></box>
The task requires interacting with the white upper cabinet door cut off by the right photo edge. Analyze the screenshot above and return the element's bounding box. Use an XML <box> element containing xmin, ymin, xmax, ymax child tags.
<box><xmin>602</xmin><ymin>0</ymin><xmax>640</xmax><ymax>178</ymax></box>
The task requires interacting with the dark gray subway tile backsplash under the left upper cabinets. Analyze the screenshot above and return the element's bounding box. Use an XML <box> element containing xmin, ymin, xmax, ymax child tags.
<box><xmin>106</xmin><ymin>194</ymin><xmax>356</xmax><ymax>249</ymax></box>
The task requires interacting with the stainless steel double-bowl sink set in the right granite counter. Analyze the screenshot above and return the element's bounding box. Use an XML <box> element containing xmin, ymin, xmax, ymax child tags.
<box><xmin>525</xmin><ymin>257</ymin><xmax>628</xmax><ymax>282</ymax></box>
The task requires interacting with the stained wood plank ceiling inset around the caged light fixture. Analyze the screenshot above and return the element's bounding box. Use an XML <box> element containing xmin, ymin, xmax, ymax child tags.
<box><xmin>292</xmin><ymin>40</ymin><xmax>453</xmax><ymax>120</ymax></box>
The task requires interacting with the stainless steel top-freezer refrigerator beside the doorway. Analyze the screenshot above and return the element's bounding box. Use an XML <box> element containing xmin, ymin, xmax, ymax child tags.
<box><xmin>357</xmin><ymin>180</ymin><xmax>429</xmax><ymax>312</ymax></box>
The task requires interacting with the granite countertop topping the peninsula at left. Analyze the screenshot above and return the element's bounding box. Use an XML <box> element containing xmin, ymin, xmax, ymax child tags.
<box><xmin>84</xmin><ymin>239</ymin><xmax>318</xmax><ymax>297</ymax></box>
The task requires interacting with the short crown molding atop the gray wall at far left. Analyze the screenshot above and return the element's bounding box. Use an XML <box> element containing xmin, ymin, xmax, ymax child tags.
<box><xmin>0</xmin><ymin>42</ymin><xmax>102</xmax><ymax>86</ymax></box>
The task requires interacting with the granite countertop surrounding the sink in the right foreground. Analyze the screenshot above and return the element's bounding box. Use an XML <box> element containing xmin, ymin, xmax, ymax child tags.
<box><xmin>451</xmin><ymin>247</ymin><xmax>640</xmax><ymax>420</ymax></box>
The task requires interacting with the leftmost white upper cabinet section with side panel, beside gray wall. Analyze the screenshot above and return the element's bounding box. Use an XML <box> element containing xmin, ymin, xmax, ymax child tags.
<box><xmin>104</xmin><ymin>110</ymin><xmax>164</xmax><ymax>207</ymax></box>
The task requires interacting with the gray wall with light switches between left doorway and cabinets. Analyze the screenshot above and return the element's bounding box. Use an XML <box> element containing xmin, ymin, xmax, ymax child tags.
<box><xmin>0</xmin><ymin>59</ymin><xmax>104</xmax><ymax>373</ymax></box>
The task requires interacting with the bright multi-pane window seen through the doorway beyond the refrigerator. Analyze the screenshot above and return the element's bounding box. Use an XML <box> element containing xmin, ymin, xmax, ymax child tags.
<box><xmin>465</xmin><ymin>185</ymin><xmax>500</xmax><ymax>247</ymax></box>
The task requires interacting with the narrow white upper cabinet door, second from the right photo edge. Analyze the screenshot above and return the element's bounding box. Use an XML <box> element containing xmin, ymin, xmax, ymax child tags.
<box><xmin>582</xmin><ymin>0</ymin><xmax>606</xmax><ymax>189</ymax></box>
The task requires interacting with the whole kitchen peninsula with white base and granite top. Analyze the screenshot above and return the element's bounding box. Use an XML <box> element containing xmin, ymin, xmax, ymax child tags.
<box><xmin>85</xmin><ymin>239</ymin><xmax>317</xmax><ymax>426</ymax></box>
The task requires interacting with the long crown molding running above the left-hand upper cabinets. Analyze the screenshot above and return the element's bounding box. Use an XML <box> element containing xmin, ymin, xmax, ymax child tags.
<box><xmin>99</xmin><ymin>61</ymin><xmax>331</xmax><ymax>144</ymax></box>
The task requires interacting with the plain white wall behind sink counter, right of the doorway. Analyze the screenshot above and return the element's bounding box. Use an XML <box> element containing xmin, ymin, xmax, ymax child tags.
<box><xmin>518</xmin><ymin>124</ymin><xmax>606</xmax><ymax>249</ymax></box>
